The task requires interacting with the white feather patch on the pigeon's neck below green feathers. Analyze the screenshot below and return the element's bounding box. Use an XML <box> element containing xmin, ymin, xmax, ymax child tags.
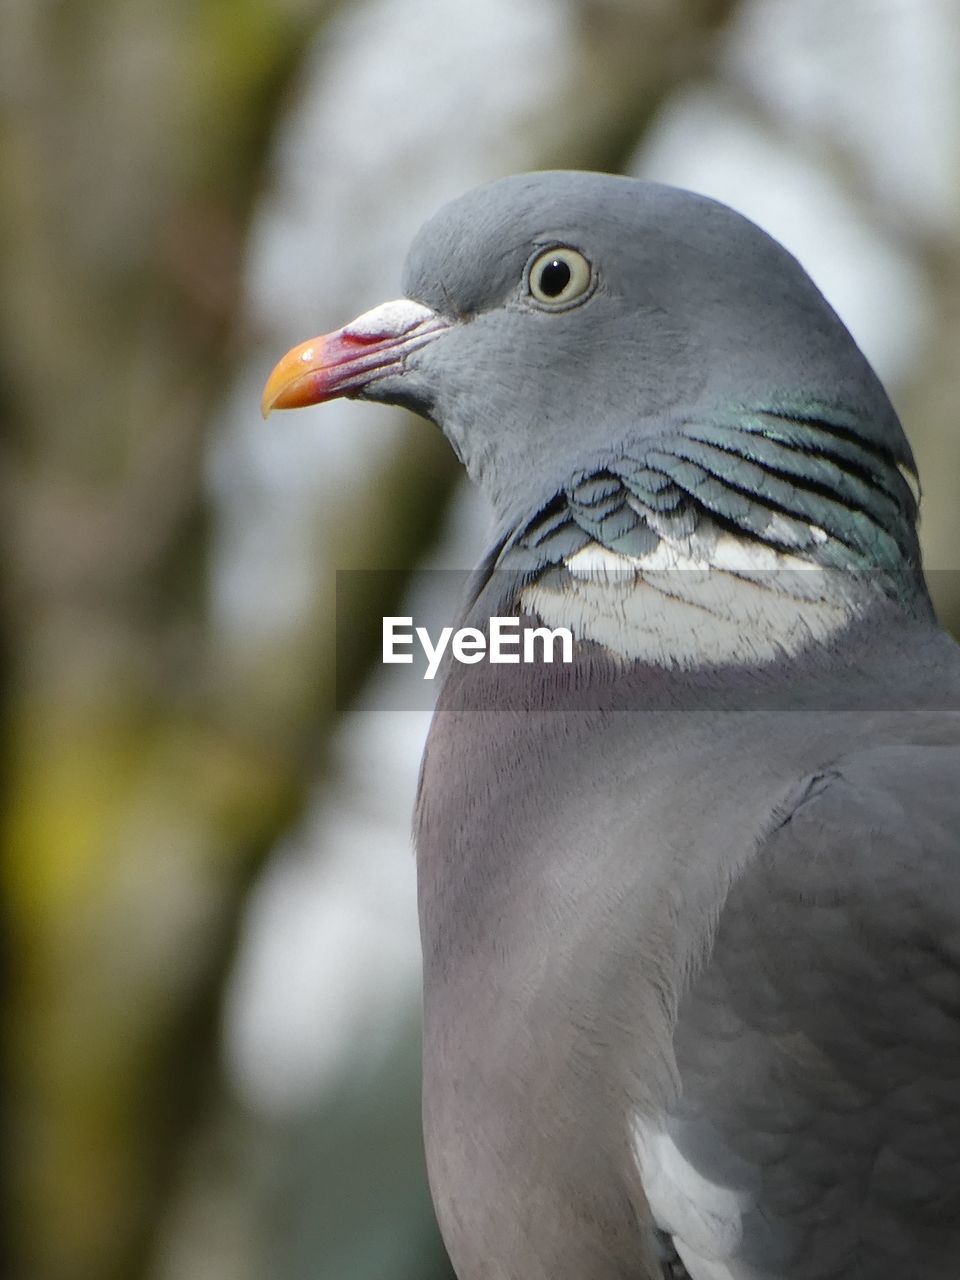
<box><xmin>521</xmin><ymin>527</ymin><xmax>854</xmax><ymax>668</ymax></box>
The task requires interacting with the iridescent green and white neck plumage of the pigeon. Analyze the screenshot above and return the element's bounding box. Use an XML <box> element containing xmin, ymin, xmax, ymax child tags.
<box><xmin>495</xmin><ymin>410</ymin><xmax>928</xmax><ymax>668</ymax></box>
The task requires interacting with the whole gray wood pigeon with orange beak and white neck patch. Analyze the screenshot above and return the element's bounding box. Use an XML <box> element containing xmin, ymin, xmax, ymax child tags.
<box><xmin>264</xmin><ymin>172</ymin><xmax>960</xmax><ymax>1280</ymax></box>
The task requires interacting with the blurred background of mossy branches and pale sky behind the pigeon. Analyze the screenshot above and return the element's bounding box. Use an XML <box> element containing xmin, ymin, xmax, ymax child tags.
<box><xmin>0</xmin><ymin>0</ymin><xmax>960</xmax><ymax>1280</ymax></box>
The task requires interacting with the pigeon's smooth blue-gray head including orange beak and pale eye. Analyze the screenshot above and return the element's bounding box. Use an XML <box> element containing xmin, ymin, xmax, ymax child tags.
<box><xmin>264</xmin><ymin>172</ymin><xmax>913</xmax><ymax>550</ymax></box>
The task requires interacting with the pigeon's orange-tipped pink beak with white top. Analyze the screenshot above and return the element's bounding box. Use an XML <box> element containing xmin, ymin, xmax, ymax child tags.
<box><xmin>260</xmin><ymin>298</ymin><xmax>449</xmax><ymax>417</ymax></box>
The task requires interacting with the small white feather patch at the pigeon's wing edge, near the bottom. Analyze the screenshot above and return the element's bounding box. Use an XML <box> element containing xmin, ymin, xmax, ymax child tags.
<box><xmin>632</xmin><ymin>1117</ymin><xmax>751</xmax><ymax>1280</ymax></box>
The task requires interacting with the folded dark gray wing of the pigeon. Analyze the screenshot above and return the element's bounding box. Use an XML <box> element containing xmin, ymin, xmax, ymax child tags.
<box><xmin>660</xmin><ymin>745</ymin><xmax>960</xmax><ymax>1280</ymax></box>
